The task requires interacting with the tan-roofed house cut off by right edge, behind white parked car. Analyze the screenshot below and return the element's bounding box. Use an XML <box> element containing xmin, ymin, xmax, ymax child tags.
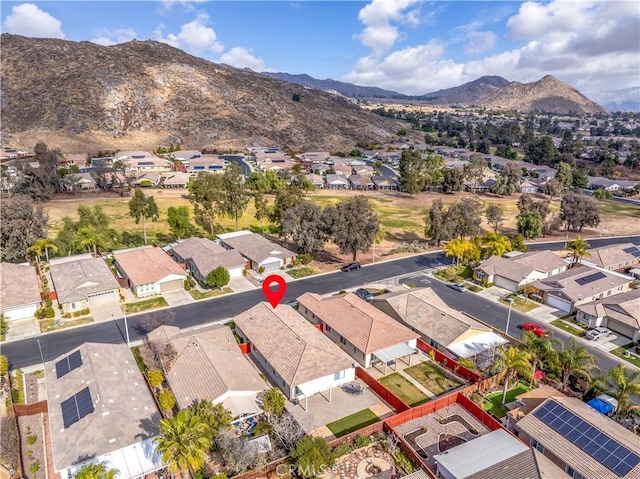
<box><xmin>576</xmin><ymin>289</ymin><xmax>640</xmax><ymax>342</ymax></box>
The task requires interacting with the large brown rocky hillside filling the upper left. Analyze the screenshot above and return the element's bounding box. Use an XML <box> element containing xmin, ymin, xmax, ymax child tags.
<box><xmin>0</xmin><ymin>34</ymin><xmax>408</xmax><ymax>151</ymax></box>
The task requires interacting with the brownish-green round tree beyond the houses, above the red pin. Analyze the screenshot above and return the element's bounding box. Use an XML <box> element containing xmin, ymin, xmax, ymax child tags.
<box><xmin>282</xmin><ymin>200</ymin><xmax>330</xmax><ymax>254</ymax></box>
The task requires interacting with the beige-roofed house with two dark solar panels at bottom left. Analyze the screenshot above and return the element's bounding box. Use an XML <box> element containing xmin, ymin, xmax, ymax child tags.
<box><xmin>44</xmin><ymin>343</ymin><xmax>164</xmax><ymax>479</ymax></box>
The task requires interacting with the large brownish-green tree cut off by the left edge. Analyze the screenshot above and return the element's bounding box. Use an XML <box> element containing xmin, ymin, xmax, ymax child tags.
<box><xmin>0</xmin><ymin>195</ymin><xmax>49</xmax><ymax>262</ymax></box>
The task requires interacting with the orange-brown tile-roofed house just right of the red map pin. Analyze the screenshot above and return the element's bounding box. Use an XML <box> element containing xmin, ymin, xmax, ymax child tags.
<box><xmin>298</xmin><ymin>293</ymin><xmax>419</xmax><ymax>368</ymax></box>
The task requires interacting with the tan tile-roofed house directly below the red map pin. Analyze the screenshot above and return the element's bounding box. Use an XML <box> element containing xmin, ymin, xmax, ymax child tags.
<box><xmin>234</xmin><ymin>302</ymin><xmax>355</xmax><ymax>409</ymax></box>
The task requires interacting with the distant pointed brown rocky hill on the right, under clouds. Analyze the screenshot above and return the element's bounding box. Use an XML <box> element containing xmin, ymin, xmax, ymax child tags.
<box><xmin>480</xmin><ymin>75</ymin><xmax>607</xmax><ymax>114</ymax></box>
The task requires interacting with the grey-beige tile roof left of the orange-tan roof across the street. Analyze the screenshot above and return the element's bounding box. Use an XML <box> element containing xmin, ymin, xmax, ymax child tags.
<box><xmin>50</xmin><ymin>258</ymin><xmax>120</xmax><ymax>304</ymax></box>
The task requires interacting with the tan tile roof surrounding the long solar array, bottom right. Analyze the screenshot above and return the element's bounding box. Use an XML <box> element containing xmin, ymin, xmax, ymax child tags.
<box><xmin>516</xmin><ymin>397</ymin><xmax>640</xmax><ymax>479</ymax></box>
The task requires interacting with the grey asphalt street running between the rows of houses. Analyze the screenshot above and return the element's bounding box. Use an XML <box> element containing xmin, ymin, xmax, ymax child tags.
<box><xmin>1</xmin><ymin>236</ymin><xmax>640</xmax><ymax>369</ymax></box>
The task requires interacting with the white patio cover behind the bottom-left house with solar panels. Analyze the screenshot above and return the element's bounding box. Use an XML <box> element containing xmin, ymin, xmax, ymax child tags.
<box><xmin>60</xmin><ymin>438</ymin><xmax>164</xmax><ymax>479</ymax></box>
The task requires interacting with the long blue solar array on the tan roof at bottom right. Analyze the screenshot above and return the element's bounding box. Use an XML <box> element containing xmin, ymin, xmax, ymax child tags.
<box><xmin>533</xmin><ymin>402</ymin><xmax>640</xmax><ymax>477</ymax></box>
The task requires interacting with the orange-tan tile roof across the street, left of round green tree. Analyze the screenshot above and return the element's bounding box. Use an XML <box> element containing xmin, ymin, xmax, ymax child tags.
<box><xmin>113</xmin><ymin>248</ymin><xmax>187</xmax><ymax>286</ymax></box>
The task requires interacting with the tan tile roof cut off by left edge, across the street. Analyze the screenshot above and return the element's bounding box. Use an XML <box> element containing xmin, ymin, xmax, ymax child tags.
<box><xmin>0</xmin><ymin>263</ymin><xmax>41</xmax><ymax>309</ymax></box>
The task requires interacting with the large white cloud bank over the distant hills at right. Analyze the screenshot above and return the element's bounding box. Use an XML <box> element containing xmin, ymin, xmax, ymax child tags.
<box><xmin>342</xmin><ymin>0</ymin><xmax>640</xmax><ymax>96</ymax></box>
